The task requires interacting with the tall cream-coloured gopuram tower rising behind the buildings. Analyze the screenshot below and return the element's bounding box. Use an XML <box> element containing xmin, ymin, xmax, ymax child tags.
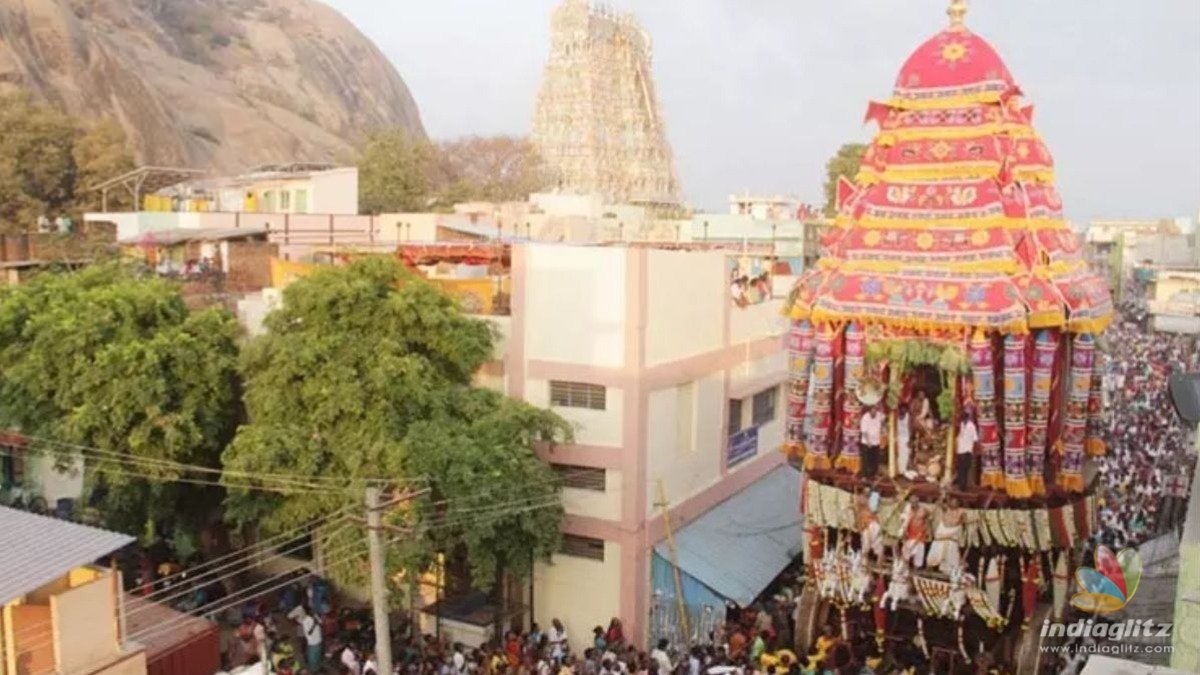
<box><xmin>533</xmin><ymin>0</ymin><xmax>680</xmax><ymax>205</ymax></box>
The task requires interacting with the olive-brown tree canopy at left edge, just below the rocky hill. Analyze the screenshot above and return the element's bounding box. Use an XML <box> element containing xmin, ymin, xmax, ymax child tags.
<box><xmin>0</xmin><ymin>94</ymin><xmax>133</xmax><ymax>232</ymax></box>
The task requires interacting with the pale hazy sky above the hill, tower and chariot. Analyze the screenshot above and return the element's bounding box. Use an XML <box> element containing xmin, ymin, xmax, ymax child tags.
<box><xmin>324</xmin><ymin>0</ymin><xmax>1200</xmax><ymax>223</ymax></box>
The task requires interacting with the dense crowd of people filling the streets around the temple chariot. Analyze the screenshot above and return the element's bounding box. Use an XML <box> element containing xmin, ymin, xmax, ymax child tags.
<box><xmin>218</xmin><ymin>303</ymin><xmax>1200</xmax><ymax>675</ymax></box>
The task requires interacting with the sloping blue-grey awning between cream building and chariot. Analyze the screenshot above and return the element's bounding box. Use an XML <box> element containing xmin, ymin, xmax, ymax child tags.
<box><xmin>654</xmin><ymin>466</ymin><xmax>802</xmax><ymax>605</ymax></box>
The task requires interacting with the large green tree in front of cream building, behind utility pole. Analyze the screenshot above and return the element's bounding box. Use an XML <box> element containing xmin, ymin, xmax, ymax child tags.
<box><xmin>224</xmin><ymin>258</ymin><xmax>570</xmax><ymax>587</ymax></box>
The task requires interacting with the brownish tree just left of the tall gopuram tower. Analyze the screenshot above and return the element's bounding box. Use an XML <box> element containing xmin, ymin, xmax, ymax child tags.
<box><xmin>437</xmin><ymin>136</ymin><xmax>552</xmax><ymax>202</ymax></box>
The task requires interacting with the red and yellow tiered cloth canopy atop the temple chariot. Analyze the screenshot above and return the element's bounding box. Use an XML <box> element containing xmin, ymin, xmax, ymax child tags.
<box><xmin>788</xmin><ymin>0</ymin><xmax>1112</xmax><ymax>333</ymax></box>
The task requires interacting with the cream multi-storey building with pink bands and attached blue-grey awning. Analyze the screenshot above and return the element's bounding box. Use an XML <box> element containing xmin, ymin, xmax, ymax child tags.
<box><xmin>491</xmin><ymin>244</ymin><xmax>800</xmax><ymax>645</ymax></box>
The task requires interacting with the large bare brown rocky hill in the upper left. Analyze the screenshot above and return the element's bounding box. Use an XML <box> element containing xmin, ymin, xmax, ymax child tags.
<box><xmin>0</xmin><ymin>0</ymin><xmax>425</xmax><ymax>172</ymax></box>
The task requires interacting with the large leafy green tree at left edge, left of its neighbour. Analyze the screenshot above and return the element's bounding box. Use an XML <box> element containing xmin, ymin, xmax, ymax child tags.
<box><xmin>0</xmin><ymin>263</ymin><xmax>239</xmax><ymax>533</ymax></box>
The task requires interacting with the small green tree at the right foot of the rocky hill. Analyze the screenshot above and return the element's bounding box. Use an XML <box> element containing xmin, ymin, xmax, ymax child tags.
<box><xmin>358</xmin><ymin>129</ymin><xmax>433</xmax><ymax>214</ymax></box>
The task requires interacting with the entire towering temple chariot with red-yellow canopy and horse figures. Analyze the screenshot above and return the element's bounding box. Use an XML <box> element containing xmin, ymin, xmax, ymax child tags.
<box><xmin>787</xmin><ymin>0</ymin><xmax>1112</xmax><ymax>673</ymax></box>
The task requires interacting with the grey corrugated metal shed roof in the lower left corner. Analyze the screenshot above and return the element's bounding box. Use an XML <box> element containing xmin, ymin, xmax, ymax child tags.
<box><xmin>0</xmin><ymin>507</ymin><xmax>133</xmax><ymax>605</ymax></box>
